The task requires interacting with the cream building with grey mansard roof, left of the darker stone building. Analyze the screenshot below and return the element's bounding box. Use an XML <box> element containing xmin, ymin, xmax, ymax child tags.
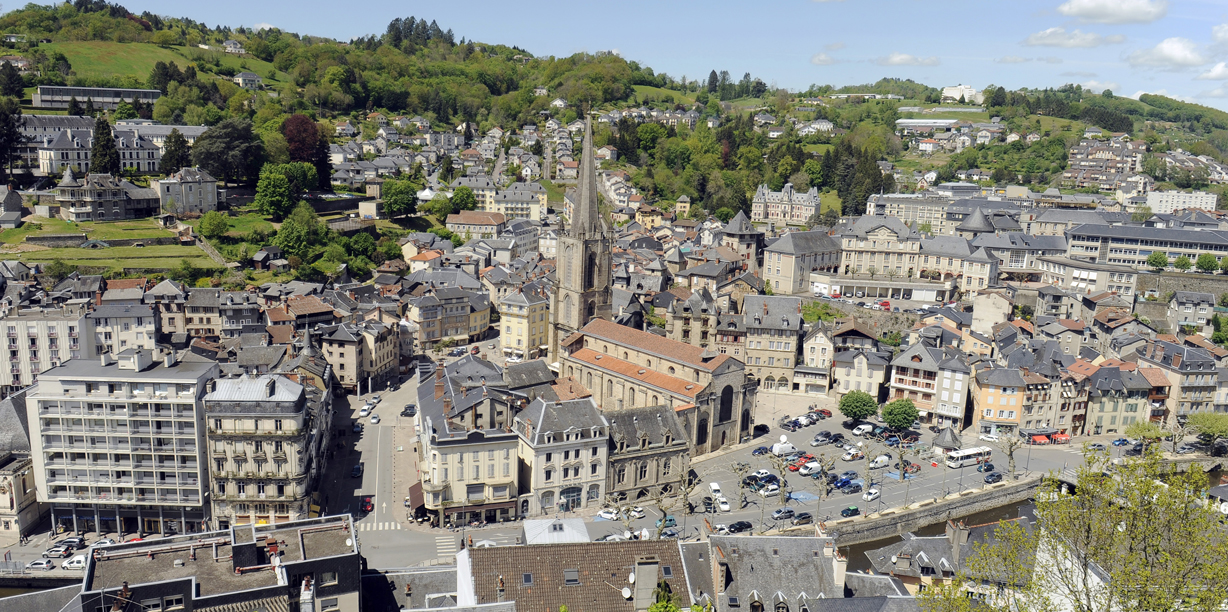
<box><xmin>512</xmin><ymin>397</ymin><xmax>610</xmax><ymax>516</ymax></box>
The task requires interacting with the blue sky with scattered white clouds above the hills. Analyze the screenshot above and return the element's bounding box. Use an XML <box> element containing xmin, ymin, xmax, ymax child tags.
<box><xmin>86</xmin><ymin>0</ymin><xmax>1228</xmax><ymax>109</ymax></box>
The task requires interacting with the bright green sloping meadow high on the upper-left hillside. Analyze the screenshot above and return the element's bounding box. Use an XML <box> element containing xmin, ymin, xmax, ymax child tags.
<box><xmin>39</xmin><ymin>41</ymin><xmax>286</xmax><ymax>81</ymax></box>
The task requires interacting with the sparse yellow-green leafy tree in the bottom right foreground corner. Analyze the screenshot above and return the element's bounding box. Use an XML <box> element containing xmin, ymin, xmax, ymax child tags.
<box><xmin>919</xmin><ymin>452</ymin><xmax>1228</xmax><ymax>612</ymax></box>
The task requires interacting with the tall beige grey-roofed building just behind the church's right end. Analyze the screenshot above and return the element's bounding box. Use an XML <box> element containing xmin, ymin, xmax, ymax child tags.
<box><xmin>743</xmin><ymin>295</ymin><xmax>806</xmax><ymax>392</ymax></box>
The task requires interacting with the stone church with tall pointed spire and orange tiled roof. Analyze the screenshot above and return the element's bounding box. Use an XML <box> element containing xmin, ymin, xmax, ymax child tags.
<box><xmin>550</xmin><ymin>123</ymin><xmax>759</xmax><ymax>456</ymax></box>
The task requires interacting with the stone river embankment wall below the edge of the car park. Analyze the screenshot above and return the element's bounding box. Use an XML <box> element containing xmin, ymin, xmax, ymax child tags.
<box><xmin>823</xmin><ymin>476</ymin><xmax>1041</xmax><ymax>546</ymax></box>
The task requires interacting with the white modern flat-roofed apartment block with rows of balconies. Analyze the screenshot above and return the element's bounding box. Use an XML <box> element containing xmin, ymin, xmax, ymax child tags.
<box><xmin>26</xmin><ymin>349</ymin><xmax>219</xmax><ymax>535</ymax></box>
